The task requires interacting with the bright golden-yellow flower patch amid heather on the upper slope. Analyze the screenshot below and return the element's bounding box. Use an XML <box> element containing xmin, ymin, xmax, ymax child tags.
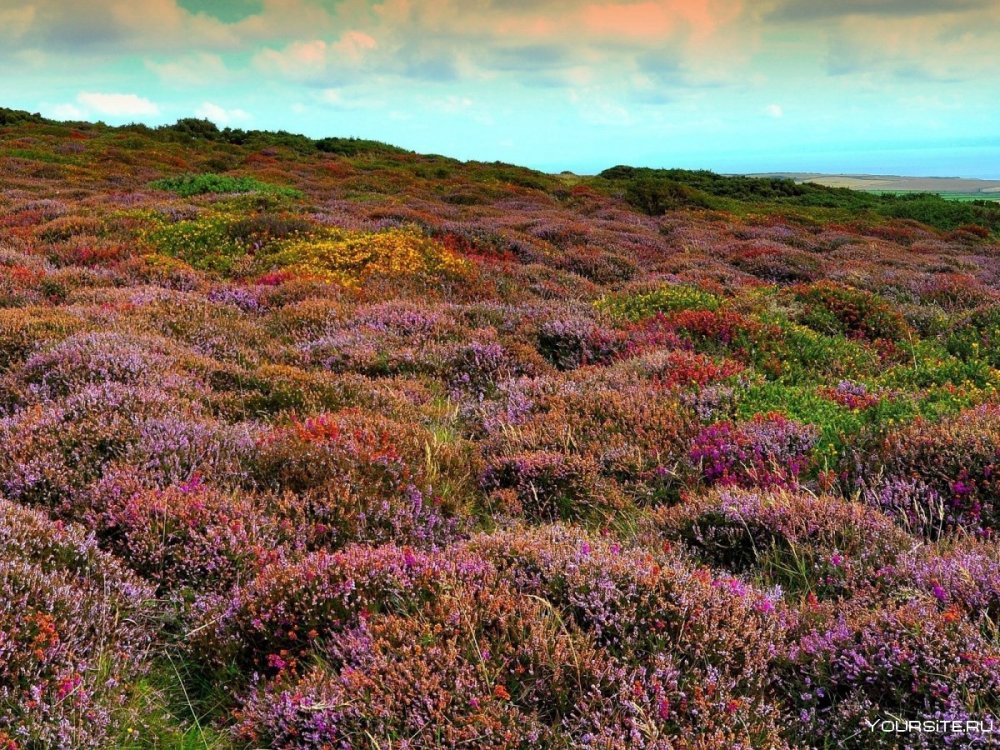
<box><xmin>271</xmin><ymin>229</ymin><xmax>469</xmax><ymax>286</ymax></box>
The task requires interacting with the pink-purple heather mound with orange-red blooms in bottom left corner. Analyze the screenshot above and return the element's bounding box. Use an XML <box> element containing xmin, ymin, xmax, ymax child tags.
<box><xmin>0</xmin><ymin>500</ymin><xmax>153</xmax><ymax>749</ymax></box>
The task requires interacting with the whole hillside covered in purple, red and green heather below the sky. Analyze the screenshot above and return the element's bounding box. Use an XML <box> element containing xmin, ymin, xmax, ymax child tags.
<box><xmin>0</xmin><ymin>110</ymin><xmax>1000</xmax><ymax>750</ymax></box>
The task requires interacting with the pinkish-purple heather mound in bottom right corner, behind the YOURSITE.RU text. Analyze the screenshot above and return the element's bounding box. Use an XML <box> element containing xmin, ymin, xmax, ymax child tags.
<box><xmin>782</xmin><ymin>603</ymin><xmax>1000</xmax><ymax>748</ymax></box>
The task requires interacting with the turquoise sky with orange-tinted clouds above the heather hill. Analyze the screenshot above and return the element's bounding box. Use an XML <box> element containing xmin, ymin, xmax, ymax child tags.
<box><xmin>0</xmin><ymin>0</ymin><xmax>1000</xmax><ymax>179</ymax></box>
